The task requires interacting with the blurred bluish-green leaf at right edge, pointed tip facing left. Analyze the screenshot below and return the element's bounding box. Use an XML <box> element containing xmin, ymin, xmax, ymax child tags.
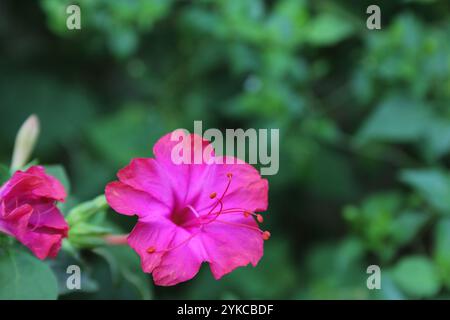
<box><xmin>400</xmin><ymin>169</ymin><xmax>450</xmax><ymax>213</ymax></box>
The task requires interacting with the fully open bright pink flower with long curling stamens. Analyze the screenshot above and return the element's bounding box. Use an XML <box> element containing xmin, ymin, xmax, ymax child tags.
<box><xmin>106</xmin><ymin>131</ymin><xmax>270</xmax><ymax>286</ymax></box>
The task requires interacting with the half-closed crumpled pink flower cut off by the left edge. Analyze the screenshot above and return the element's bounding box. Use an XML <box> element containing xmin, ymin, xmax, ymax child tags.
<box><xmin>0</xmin><ymin>166</ymin><xmax>68</xmax><ymax>259</ymax></box>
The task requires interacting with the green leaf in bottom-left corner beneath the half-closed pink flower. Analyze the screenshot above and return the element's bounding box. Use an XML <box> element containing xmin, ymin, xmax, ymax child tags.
<box><xmin>0</xmin><ymin>249</ymin><xmax>58</xmax><ymax>300</ymax></box>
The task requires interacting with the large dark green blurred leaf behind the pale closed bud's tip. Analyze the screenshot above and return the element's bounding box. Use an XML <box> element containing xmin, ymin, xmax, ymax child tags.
<box><xmin>0</xmin><ymin>74</ymin><xmax>97</xmax><ymax>154</ymax></box>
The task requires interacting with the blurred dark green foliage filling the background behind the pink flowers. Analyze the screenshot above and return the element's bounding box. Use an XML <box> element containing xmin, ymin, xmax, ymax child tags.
<box><xmin>0</xmin><ymin>0</ymin><xmax>450</xmax><ymax>299</ymax></box>
